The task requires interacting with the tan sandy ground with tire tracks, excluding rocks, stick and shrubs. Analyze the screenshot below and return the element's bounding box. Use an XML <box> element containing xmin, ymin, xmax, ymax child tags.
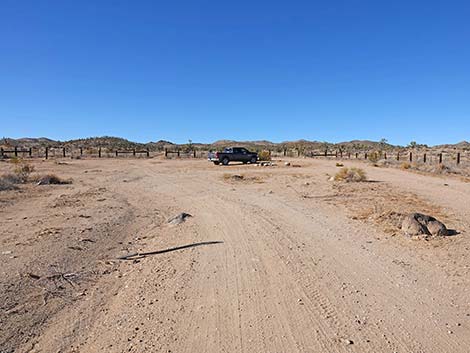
<box><xmin>0</xmin><ymin>159</ymin><xmax>470</xmax><ymax>353</ymax></box>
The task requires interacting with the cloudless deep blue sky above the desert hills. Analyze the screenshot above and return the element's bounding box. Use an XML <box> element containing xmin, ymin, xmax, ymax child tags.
<box><xmin>0</xmin><ymin>0</ymin><xmax>470</xmax><ymax>144</ymax></box>
